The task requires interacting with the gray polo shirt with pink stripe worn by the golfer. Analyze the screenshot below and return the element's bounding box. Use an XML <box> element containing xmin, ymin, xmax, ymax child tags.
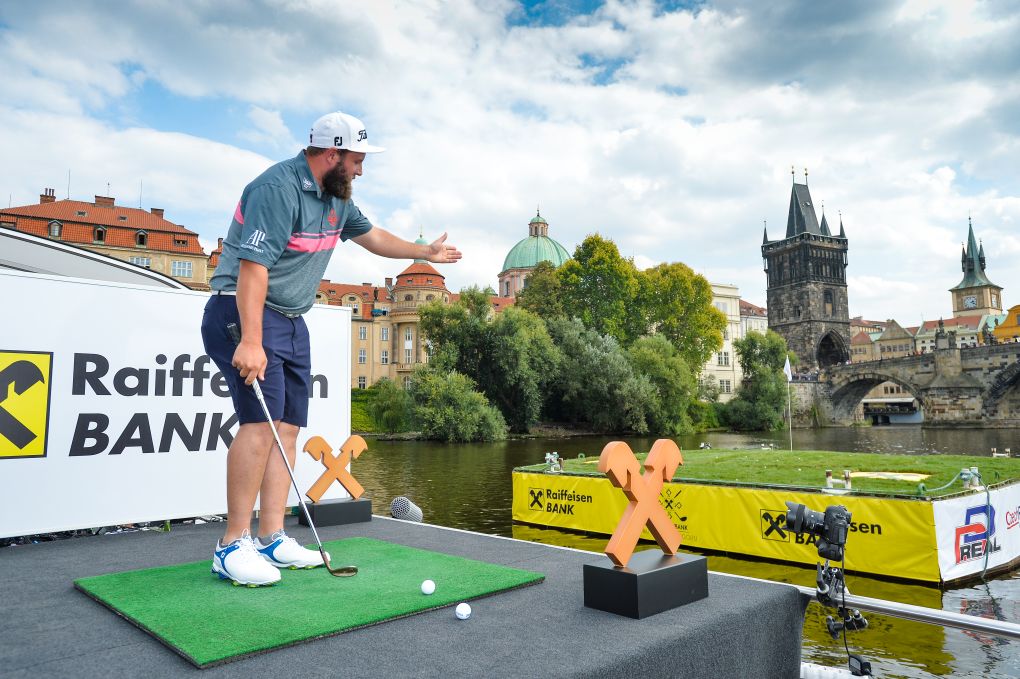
<box><xmin>209</xmin><ymin>151</ymin><xmax>372</xmax><ymax>315</ymax></box>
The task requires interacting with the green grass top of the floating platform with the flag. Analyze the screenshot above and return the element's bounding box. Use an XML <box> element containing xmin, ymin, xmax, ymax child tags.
<box><xmin>521</xmin><ymin>450</ymin><xmax>1020</xmax><ymax>498</ymax></box>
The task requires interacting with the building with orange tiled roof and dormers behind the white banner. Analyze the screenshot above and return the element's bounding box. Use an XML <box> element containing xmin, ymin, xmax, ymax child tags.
<box><xmin>0</xmin><ymin>189</ymin><xmax>209</xmax><ymax>290</ymax></box>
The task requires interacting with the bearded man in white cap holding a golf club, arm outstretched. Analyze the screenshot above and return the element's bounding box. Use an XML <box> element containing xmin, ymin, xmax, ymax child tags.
<box><xmin>202</xmin><ymin>111</ymin><xmax>461</xmax><ymax>585</ymax></box>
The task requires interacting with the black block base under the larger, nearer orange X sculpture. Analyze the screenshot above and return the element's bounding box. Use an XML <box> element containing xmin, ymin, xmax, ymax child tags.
<box><xmin>584</xmin><ymin>550</ymin><xmax>708</xmax><ymax>619</ymax></box>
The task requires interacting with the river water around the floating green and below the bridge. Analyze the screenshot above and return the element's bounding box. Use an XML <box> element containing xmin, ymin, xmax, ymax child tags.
<box><xmin>354</xmin><ymin>426</ymin><xmax>1020</xmax><ymax>678</ymax></box>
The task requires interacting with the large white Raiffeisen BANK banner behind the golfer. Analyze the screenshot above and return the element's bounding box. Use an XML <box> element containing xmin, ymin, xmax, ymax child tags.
<box><xmin>0</xmin><ymin>269</ymin><xmax>351</xmax><ymax>537</ymax></box>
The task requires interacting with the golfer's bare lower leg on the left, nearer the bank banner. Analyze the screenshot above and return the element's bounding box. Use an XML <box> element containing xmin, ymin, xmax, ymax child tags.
<box><xmin>221</xmin><ymin>422</ymin><xmax>273</xmax><ymax>544</ymax></box>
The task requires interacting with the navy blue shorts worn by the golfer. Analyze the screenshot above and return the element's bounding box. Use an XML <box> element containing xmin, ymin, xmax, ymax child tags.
<box><xmin>202</xmin><ymin>295</ymin><xmax>311</xmax><ymax>427</ymax></box>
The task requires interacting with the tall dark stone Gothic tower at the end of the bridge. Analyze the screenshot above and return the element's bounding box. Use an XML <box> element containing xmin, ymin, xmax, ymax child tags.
<box><xmin>762</xmin><ymin>174</ymin><xmax>850</xmax><ymax>370</ymax></box>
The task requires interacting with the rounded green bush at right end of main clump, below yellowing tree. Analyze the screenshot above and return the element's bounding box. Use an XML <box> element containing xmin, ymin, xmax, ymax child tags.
<box><xmin>627</xmin><ymin>334</ymin><xmax>698</xmax><ymax>436</ymax></box>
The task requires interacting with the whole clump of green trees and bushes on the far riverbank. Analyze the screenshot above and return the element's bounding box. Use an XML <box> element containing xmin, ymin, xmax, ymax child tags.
<box><xmin>368</xmin><ymin>234</ymin><xmax>785</xmax><ymax>440</ymax></box>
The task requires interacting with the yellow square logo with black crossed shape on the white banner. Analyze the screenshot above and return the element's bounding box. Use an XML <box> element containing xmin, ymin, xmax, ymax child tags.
<box><xmin>0</xmin><ymin>352</ymin><xmax>53</xmax><ymax>460</ymax></box>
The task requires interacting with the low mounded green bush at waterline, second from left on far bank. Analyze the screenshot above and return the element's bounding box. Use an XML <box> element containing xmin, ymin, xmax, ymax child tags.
<box><xmin>410</xmin><ymin>366</ymin><xmax>507</xmax><ymax>442</ymax></box>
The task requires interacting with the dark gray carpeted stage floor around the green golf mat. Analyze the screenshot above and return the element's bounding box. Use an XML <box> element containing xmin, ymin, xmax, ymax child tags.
<box><xmin>0</xmin><ymin>517</ymin><xmax>806</xmax><ymax>679</ymax></box>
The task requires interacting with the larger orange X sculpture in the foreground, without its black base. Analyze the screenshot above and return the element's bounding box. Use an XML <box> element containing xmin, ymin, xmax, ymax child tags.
<box><xmin>599</xmin><ymin>438</ymin><xmax>683</xmax><ymax>568</ymax></box>
